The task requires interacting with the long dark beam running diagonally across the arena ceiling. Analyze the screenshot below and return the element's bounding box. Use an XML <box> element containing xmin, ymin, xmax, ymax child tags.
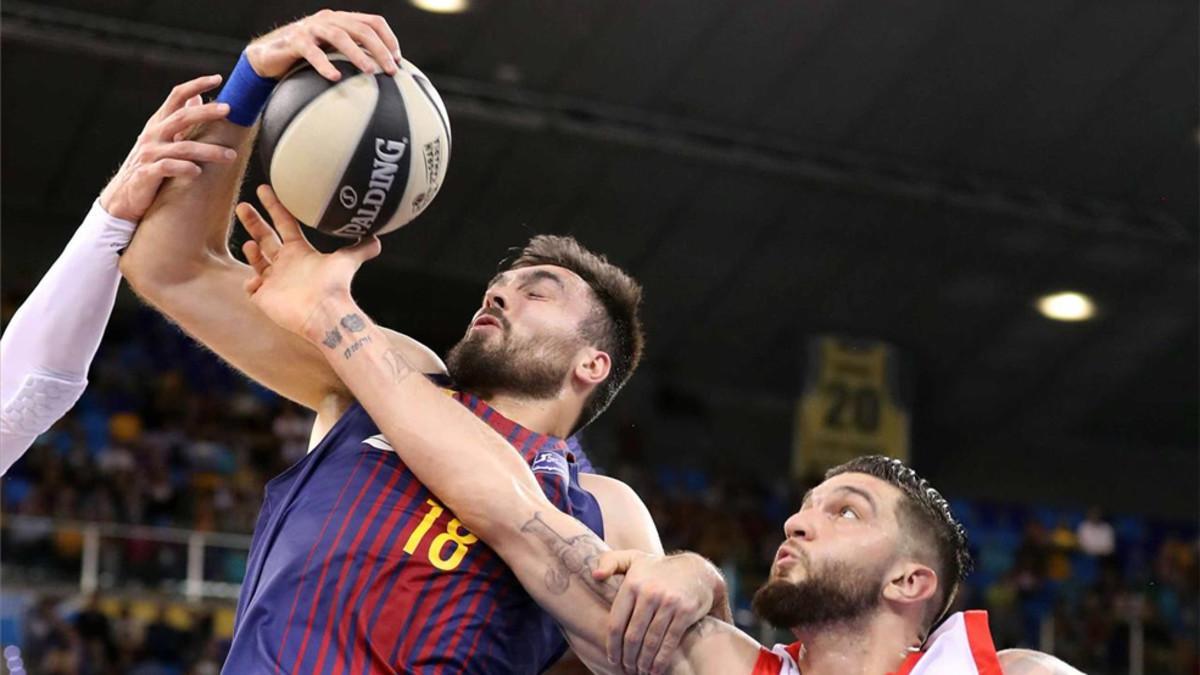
<box><xmin>0</xmin><ymin>0</ymin><xmax>1195</xmax><ymax>243</ymax></box>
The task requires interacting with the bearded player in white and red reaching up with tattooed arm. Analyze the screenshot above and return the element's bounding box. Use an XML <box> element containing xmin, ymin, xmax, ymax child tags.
<box><xmin>239</xmin><ymin>180</ymin><xmax>1094</xmax><ymax>675</ymax></box>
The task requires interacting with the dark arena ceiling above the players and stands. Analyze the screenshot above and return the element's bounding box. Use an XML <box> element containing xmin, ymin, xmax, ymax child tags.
<box><xmin>2</xmin><ymin>0</ymin><xmax>1200</xmax><ymax>504</ymax></box>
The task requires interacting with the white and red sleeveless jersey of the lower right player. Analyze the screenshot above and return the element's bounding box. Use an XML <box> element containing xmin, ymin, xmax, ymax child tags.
<box><xmin>751</xmin><ymin>610</ymin><xmax>1002</xmax><ymax>675</ymax></box>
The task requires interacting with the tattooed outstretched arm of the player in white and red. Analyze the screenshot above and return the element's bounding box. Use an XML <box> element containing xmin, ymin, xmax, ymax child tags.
<box><xmin>232</xmin><ymin>192</ymin><xmax>758</xmax><ymax>675</ymax></box>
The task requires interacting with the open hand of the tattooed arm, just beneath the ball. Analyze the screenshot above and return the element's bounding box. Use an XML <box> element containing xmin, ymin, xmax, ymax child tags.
<box><xmin>236</xmin><ymin>185</ymin><xmax>380</xmax><ymax>339</ymax></box>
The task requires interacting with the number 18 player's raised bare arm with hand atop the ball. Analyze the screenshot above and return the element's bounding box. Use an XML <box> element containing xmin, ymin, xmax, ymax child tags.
<box><xmin>121</xmin><ymin>10</ymin><xmax>442</xmax><ymax>417</ymax></box>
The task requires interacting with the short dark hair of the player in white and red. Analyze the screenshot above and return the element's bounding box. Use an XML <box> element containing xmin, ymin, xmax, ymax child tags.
<box><xmin>824</xmin><ymin>455</ymin><xmax>972</xmax><ymax>632</ymax></box>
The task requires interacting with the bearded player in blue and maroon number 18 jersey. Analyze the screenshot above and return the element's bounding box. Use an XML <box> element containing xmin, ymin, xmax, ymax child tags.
<box><xmin>121</xmin><ymin>11</ymin><xmax>727</xmax><ymax>675</ymax></box>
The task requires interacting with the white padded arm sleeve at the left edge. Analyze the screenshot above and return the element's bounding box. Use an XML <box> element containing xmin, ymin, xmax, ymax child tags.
<box><xmin>0</xmin><ymin>201</ymin><xmax>136</xmax><ymax>474</ymax></box>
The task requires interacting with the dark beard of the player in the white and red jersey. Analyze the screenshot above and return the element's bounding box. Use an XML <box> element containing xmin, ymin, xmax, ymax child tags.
<box><xmin>751</xmin><ymin>558</ymin><xmax>882</xmax><ymax>629</ymax></box>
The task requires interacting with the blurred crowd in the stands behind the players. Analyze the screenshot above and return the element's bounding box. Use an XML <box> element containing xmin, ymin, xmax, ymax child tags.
<box><xmin>2</xmin><ymin>304</ymin><xmax>1200</xmax><ymax>675</ymax></box>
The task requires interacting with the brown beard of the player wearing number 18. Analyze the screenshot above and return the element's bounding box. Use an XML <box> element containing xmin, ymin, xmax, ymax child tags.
<box><xmin>446</xmin><ymin>317</ymin><xmax>582</xmax><ymax>399</ymax></box>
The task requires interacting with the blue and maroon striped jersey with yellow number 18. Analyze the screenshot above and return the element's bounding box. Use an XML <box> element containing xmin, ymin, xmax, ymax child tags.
<box><xmin>223</xmin><ymin>393</ymin><xmax>604</xmax><ymax>675</ymax></box>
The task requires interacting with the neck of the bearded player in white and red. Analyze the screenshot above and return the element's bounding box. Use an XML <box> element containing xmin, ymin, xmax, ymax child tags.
<box><xmin>793</xmin><ymin>614</ymin><xmax>916</xmax><ymax>675</ymax></box>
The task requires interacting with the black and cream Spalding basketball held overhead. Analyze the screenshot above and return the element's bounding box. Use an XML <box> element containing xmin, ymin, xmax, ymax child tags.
<box><xmin>259</xmin><ymin>55</ymin><xmax>450</xmax><ymax>238</ymax></box>
